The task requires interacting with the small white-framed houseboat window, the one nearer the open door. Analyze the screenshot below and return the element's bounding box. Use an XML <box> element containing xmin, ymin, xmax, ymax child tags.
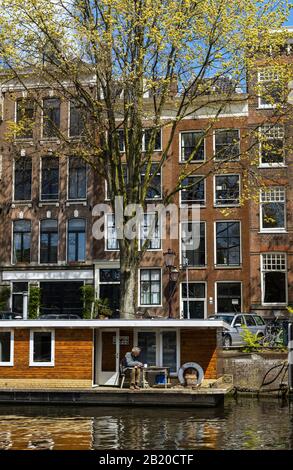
<box><xmin>30</xmin><ymin>331</ymin><xmax>55</xmax><ymax>366</ymax></box>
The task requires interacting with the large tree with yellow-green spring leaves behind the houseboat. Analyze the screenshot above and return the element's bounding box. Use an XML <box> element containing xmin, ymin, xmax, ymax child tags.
<box><xmin>0</xmin><ymin>0</ymin><xmax>287</xmax><ymax>318</ymax></box>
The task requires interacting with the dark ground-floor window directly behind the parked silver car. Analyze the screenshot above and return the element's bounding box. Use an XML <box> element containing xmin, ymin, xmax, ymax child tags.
<box><xmin>216</xmin><ymin>282</ymin><xmax>241</xmax><ymax>313</ymax></box>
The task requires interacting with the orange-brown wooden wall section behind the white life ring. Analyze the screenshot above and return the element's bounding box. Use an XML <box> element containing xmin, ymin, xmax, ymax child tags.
<box><xmin>180</xmin><ymin>329</ymin><xmax>217</xmax><ymax>379</ymax></box>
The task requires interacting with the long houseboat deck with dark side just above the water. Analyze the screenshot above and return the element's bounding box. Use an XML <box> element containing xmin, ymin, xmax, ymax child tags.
<box><xmin>0</xmin><ymin>384</ymin><xmax>233</xmax><ymax>407</ymax></box>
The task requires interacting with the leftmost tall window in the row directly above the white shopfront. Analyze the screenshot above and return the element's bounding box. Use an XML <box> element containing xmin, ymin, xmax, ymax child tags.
<box><xmin>13</xmin><ymin>220</ymin><xmax>31</xmax><ymax>263</ymax></box>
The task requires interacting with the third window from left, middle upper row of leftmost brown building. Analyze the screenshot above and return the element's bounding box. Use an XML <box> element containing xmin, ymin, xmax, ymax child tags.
<box><xmin>68</xmin><ymin>157</ymin><xmax>87</xmax><ymax>199</ymax></box>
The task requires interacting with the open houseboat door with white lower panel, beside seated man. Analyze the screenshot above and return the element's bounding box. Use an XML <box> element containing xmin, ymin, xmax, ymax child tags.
<box><xmin>98</xmin><ymin>328</ymin><xmax>120</xmax><ymax>386</ymax></box>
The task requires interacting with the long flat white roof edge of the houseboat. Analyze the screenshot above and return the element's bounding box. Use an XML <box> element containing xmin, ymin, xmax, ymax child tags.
<box><xmin>0</xmin><ymin>318</ymin><xmax>229</xmax><ymax>329</ymax></box>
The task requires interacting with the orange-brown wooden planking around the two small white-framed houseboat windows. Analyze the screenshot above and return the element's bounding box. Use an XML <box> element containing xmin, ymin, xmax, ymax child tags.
<box><xmin>0</xmin><ymin>328</ymin><xmax>93</xmax><ymax>380</ymax></box>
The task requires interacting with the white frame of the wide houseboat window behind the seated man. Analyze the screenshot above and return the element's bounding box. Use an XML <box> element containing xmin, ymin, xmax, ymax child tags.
<box><xmin>133</xmin><ymin>328</ymin><xmax>181</xmax><ymax>377</ymax></box>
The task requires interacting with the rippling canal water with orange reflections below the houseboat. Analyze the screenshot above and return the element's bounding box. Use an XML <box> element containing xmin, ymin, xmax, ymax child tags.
<box><xmin>0</xmin><ymin>398</ymin><xmax>293</xmax><ymax>450</ymax></box>
